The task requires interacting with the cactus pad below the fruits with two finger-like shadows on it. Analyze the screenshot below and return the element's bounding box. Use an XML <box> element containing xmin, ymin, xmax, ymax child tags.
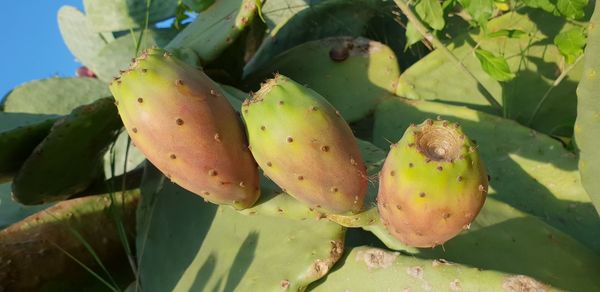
<box><xmin>137</xmin><ymin>165</ymin><xmax>344</xmax><ymax>291</ymax></box>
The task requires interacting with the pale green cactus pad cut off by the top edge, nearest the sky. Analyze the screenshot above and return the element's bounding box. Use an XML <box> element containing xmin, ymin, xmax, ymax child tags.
<box><xmin>83</xmin><ymin>0</ymin><xmax>177</xmax><ymax>32</ymax></box>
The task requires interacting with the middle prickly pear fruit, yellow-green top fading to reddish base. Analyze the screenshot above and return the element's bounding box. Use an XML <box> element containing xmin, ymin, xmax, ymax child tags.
<box><xmin>242</xmin><ymin>75</ymin><xmax>367</xmax><ymax>213</ymax></box>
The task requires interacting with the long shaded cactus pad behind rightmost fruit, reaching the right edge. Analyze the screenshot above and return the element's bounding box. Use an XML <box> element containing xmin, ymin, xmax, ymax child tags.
<box><xmin>374</xmin><ymin>98</ymin><xmax>600</xmax><ymax>252</ymax></box>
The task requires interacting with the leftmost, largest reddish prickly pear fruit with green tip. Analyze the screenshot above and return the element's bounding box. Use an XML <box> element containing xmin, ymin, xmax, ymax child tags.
<box><xmin>110</xmin><ymin>49</ymin><xmax>259</xmax><ymax>209</ymax></box>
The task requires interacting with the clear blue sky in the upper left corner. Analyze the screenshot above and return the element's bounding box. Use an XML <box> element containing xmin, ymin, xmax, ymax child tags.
<box><xmin>0</xmin><ymin>0</ymin><xmax>83</xmax><ymax>99</ymax></box>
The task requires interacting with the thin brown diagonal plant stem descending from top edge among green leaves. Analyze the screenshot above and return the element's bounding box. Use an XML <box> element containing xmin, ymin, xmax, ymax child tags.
<box><xmin>394</xmin><ymin>0</ymin><xmax>502</xmax><ymax>109</ymax></box>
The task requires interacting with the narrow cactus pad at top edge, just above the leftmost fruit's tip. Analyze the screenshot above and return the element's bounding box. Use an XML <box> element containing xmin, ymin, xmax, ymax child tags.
<box><xmin>166</xmin><ymin>0</ymin><xmax>256</xmax><ymax>64</ymax></box>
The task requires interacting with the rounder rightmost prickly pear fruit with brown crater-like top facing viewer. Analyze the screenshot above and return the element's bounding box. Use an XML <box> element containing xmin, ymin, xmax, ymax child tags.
<box><xmin>377</xmin><ymin>120</ymin><xmax>488</xmax><ymax>247</ymax></box>
